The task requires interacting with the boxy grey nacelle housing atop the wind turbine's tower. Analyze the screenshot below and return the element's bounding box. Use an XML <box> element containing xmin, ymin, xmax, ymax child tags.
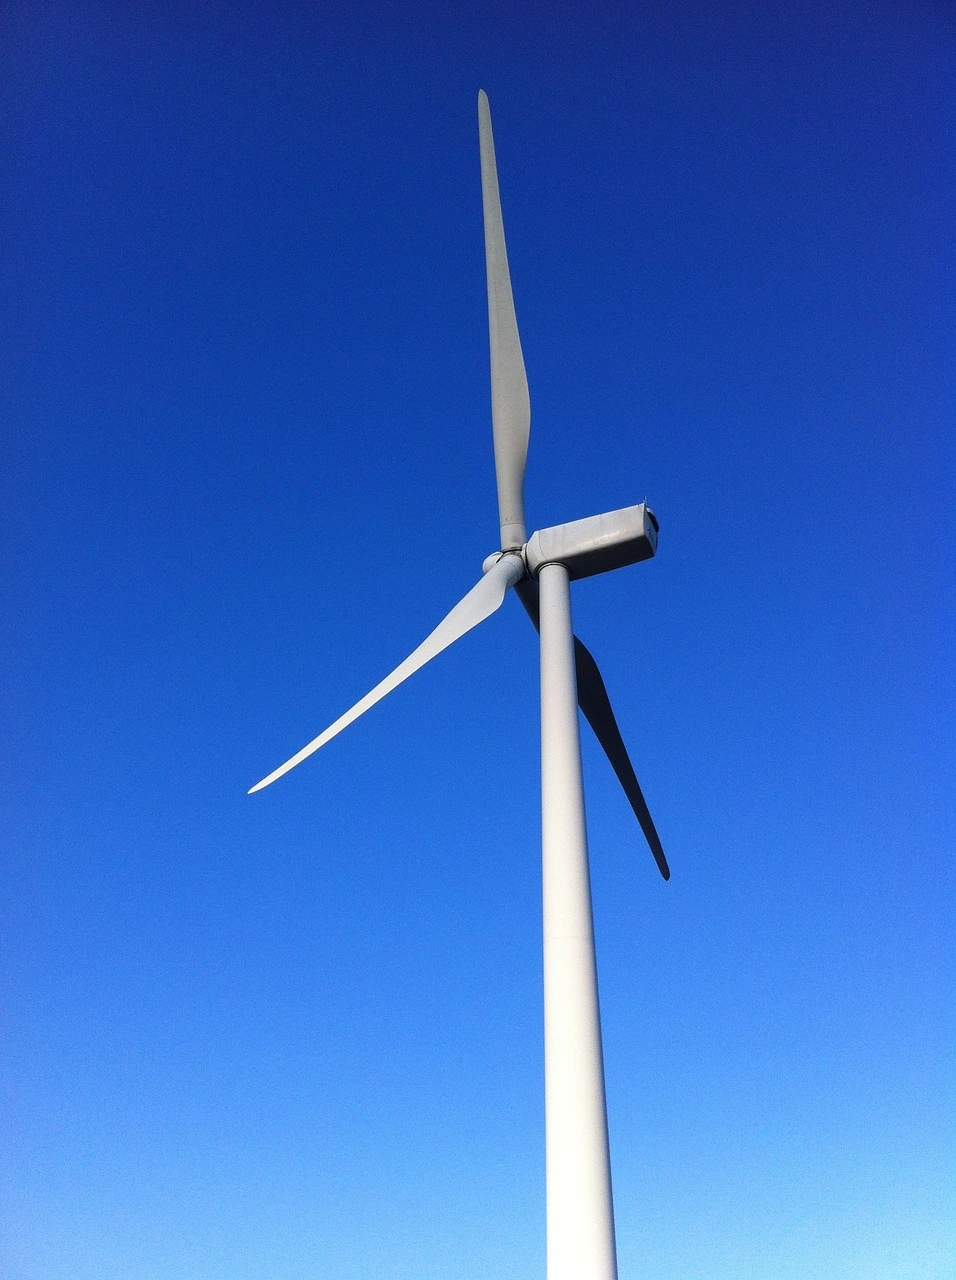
<box><xmin>522</xmin><ymin>502</ymin><xmax>658</xmax><ymax>580</ymax></box>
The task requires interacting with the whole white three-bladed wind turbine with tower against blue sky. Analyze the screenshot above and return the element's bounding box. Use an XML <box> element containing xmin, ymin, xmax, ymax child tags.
<box><xmin>250</xmin><ymin>91</ymin><xmax>671</xmax><ymax>1280</ymax></box>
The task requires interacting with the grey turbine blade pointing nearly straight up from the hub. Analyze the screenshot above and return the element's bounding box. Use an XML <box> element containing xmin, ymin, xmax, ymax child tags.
<box><xmin>479</xmin><ymin>90</ymin><xmax>531</xmax><ymax>550</ymax></box>
